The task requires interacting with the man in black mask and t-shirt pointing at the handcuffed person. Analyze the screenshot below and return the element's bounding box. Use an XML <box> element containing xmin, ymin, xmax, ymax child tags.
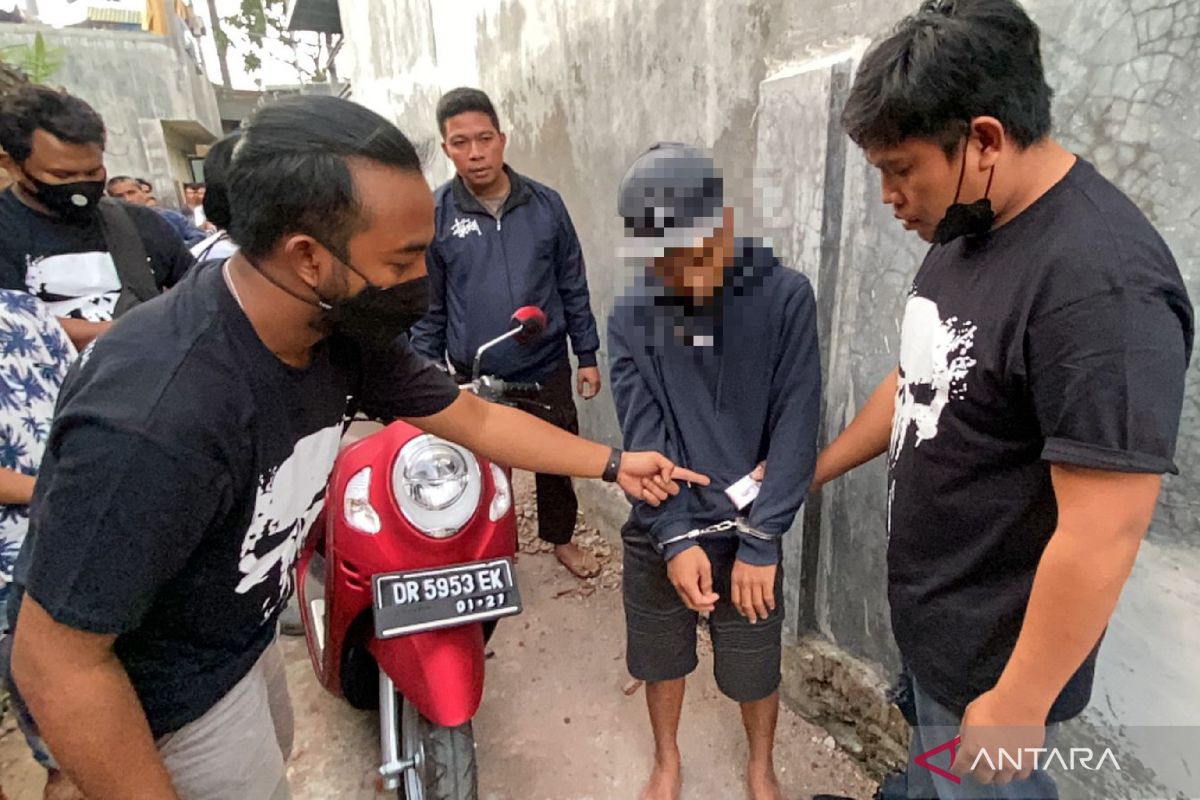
<box><xmin>8</xmin><ymin>96</ymin><xmax>707</xmax><ymax>800</ymax></box>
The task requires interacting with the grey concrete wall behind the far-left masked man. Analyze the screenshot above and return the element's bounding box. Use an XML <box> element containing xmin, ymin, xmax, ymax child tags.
<box><xmin>0</xmin><ymin>25</ymin><xmax>221</xmax><ymax>205</ymax></box>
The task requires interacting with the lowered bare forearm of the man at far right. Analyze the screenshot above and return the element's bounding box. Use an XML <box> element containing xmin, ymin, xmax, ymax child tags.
<box><xmin>996</xmin><ymin>529</ymin><xmax>1141</xmax><ymax>715</ymax></box>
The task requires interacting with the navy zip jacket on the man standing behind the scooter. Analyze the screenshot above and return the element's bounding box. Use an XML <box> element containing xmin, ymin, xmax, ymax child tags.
<box><xmin>410</xmin><ymin>167</ymin><xmax>600</xmax><ymax>380</ymax></box>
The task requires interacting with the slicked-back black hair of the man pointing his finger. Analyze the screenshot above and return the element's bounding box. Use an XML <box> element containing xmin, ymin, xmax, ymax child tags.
<box><xmin>228</xmin><ymin>95</ymin><xmax>421</xmax><ymax>260</ymax></box>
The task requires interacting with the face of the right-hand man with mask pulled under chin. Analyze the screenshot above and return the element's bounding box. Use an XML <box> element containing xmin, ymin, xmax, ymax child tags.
<box><xmin>866</xmin><ymin>138</ymin><xmax>964</xmax><ymax>241</ymax></box>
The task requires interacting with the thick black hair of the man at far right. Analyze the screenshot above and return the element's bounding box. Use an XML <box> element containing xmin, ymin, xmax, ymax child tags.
<box><xmin>841</xmin><ymin>0</ymin><xmax>1054</xmax><ymax>156</ymax></box>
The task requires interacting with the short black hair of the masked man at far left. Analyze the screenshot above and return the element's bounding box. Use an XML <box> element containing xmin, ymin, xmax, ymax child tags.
<box><xmin>0</xmin><ymin>86</ymin><xmax>106</xmax><ymax>164</ymax></box>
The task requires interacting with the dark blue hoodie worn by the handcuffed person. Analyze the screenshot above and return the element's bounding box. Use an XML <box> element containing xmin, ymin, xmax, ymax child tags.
<box><xmin>608</xmin><ymin>239</ymin><xmax>821</xmax><ymax>566</ymax></box>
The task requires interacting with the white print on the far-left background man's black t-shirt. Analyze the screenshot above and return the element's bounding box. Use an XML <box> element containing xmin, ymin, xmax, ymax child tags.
<box><xmin>25</xmin><ymin>251</ymin><xmax>121</xmax><ymax>323</ymax></box>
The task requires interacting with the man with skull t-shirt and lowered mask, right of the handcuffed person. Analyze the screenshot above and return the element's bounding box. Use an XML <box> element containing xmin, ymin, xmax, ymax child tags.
<box><xmin>814</xmin><ymin>0</ymin><xmax>1193</xmax><ymax>800</ymax></box>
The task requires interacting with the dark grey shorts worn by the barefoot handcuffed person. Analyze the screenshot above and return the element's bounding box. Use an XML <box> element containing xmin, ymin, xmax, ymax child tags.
<box><xmin>620</xmin><ymin>524</ymin><xmax>784</xmax><ymax>703</ymax></box>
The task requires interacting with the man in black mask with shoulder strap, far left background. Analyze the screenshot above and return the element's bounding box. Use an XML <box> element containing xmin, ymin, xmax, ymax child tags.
<box><xmin>0</xmin><ymin>86</ymin><xmax>192</xmax><ymax>349</ymax></box>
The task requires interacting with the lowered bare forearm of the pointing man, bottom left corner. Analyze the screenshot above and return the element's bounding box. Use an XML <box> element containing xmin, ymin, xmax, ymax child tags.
<box><xmin>12</xmin><ymin>628</ymin><xmax>176</xmax><ymax>800</ymax></box>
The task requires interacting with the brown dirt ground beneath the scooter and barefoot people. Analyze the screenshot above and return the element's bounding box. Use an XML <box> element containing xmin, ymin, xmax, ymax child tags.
<box><xmin>0</xmin><ymin>479</ymin><xmax>875</xmax><ymax>800</ymax></box>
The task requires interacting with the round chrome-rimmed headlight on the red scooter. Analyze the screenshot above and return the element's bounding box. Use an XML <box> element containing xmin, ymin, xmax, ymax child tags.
<box><xmin>391</xmin><ymin>434</ymin><xmax>482</xmax><ymax>539</ymax></box>
